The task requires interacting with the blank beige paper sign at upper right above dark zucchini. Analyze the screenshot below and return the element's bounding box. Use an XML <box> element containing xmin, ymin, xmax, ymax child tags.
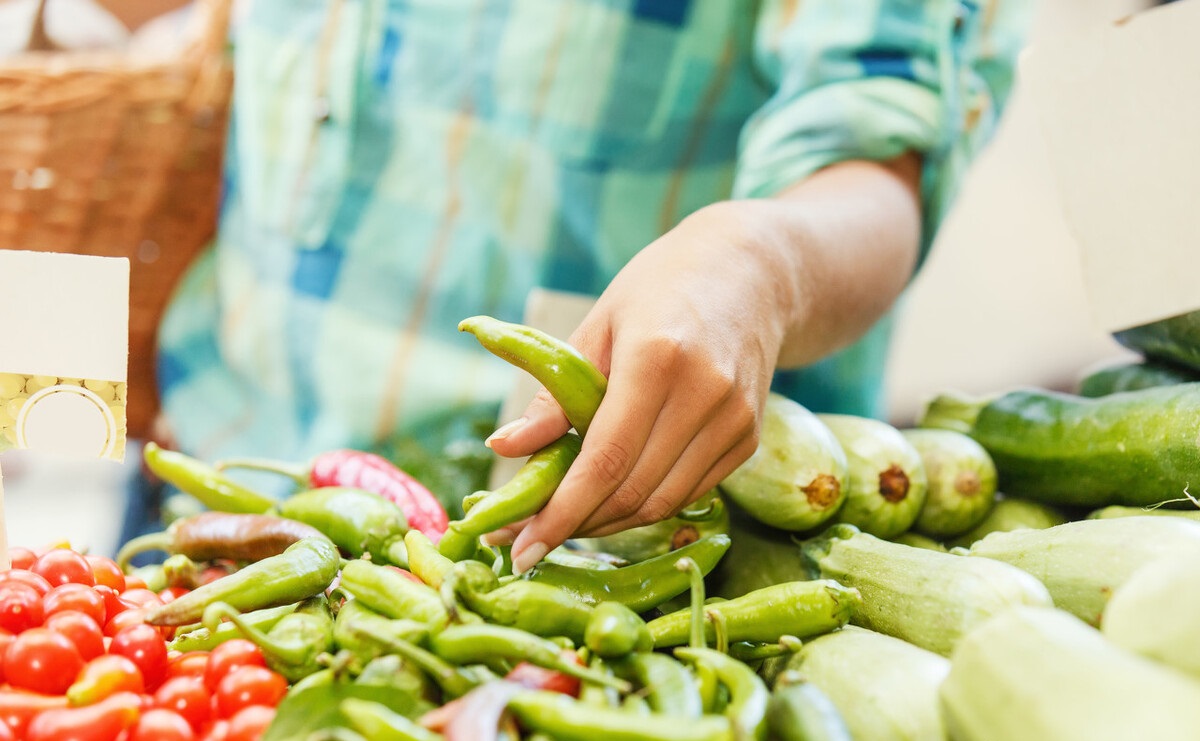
<box><xmin>1014</xmin><ymin>2</ymin><xmax>1200</xmax><ymax>331</ymax></box>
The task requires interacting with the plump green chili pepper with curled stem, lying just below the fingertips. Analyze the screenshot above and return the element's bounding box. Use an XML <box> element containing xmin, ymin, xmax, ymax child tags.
<box><xmin>442</xmin><ymin>561</ymin><xmax>590</xmax><ymax>643</ymax></box>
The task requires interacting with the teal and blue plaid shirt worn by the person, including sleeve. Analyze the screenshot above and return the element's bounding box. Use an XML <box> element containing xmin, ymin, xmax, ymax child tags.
<box><xmin>160</xmin><ymin>0</ymin><xmax>1031</xmax><ymax>460</ymax></box>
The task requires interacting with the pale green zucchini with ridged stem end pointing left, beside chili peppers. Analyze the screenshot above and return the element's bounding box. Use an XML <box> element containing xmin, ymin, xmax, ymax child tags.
<box><xmin>802</xmin><ymin>524</ymin><xmax>1052</xmax><ymax>656</ymax></box>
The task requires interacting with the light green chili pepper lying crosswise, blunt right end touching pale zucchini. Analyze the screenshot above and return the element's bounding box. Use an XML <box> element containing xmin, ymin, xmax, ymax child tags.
<box><xmin>648</xmin><ymin>579</ymin><xmax>863</xmax><ymax>647</ymax></box>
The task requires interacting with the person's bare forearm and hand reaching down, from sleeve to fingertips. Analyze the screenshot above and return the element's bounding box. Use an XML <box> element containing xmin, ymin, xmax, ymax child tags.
<box><xmin>490</xmin><ymin>149</ymin><xmax>920</xmax><ymax>571</ymax></box>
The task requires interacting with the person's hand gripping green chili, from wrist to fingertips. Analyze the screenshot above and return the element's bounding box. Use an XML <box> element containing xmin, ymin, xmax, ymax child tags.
<box><xmin>490</xmin><ymin>204</ymin><xmax>790</xmax><ymax>571</ymax></box>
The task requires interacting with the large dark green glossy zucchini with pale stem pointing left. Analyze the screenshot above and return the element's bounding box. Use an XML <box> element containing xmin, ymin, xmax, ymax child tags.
<box><xmin>920</xmin><ymin>384</ymin><xmax>1200</xmax><ymax>508</ymax></box>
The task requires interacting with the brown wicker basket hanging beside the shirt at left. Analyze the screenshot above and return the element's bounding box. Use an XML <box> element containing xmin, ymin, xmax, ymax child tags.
<box><xmin>0</xmin><ymin>0</ymin><xmax>233</xmax><ymax>436</ymax></box>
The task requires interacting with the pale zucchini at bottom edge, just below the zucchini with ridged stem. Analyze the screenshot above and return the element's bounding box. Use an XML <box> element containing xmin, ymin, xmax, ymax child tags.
<box><xmin>785</xmin><ymin>626</ymin><xmax>950</xmax><ymax>741</ymax></box>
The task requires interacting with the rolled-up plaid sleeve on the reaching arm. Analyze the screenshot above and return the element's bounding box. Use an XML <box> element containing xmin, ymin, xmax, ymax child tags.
<box><xmin>734</xmin><ymin>0</ymin><xmax>1032</xmax><ymax>255</ymax></box>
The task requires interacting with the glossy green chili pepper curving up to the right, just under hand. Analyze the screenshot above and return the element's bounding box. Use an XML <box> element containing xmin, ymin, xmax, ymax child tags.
<box><xmin>526</xmin><ymin>534</ymin><xmax>730</xmax><ymax>613</ymax></box>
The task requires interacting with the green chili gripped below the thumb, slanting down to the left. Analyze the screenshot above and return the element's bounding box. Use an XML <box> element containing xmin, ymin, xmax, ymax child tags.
<box><xmin>438</xmin><ymin>433</ymin><xmax>581</xmax><ymax>561</ymax></box>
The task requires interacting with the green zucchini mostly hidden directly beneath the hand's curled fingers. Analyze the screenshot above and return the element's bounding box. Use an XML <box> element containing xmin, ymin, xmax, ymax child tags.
<box><xmin>576</xmin><ymin>489</ymin><xmax>730</xmax><ymax>564</ymax></box>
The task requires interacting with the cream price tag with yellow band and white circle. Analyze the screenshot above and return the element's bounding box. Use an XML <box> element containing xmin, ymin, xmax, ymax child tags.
<box><xmin>0</xmin><ymin>249</ymin><xmax>130</xmax><ymax>567</ymax></box>
